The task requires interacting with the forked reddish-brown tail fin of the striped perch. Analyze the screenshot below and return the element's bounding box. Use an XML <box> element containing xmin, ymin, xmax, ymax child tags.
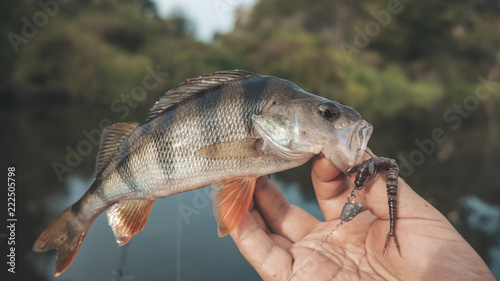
<box><xmin>33</xmin><ymin>207</ymin><xmax>92</xmax><ymax>276</ymax></box>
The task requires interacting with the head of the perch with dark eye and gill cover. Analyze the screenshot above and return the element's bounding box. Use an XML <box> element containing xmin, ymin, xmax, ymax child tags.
<box><xmin>252</xmin><ymin>83</ymin><xmax>373</xmax><ymax>172</ymax></box>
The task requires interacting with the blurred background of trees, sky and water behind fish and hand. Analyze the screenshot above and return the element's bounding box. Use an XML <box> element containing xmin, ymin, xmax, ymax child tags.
<box><xmin>0</xmin><ymin>0</ymin><xmax>500</xmax><ymax>281</ymax></box>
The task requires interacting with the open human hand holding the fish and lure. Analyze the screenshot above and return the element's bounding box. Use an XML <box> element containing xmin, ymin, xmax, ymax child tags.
<box><xmin>230</xmin><ymin>152</ymin><xmax>495</xmax><ymax>280</ymax></box>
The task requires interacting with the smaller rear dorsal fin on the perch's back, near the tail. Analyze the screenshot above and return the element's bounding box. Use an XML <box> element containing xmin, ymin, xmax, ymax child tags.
<box><xmin>94</xmin><ymin>123</ymin><xmax>139</xmax><ymax>179</ymax></box>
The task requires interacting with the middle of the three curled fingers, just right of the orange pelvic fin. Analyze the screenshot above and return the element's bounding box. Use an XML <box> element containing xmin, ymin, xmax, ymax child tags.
<box><xmin>254</xmin><ymin>177</ymin><xmax>319</xmax><ymax>242</ymax></box>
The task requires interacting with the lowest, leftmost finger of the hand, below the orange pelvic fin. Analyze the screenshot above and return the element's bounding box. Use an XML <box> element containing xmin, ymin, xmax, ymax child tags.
<box><xmin>230</xmin><ymin>210</ymin><xmax>292</xmax><ymax>280</ymax></box>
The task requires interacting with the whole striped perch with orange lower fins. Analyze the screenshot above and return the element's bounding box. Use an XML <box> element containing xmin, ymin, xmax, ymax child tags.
<box><xmin>33</xmin><ymin>70</ymin><xmax>371</xmax><ymax>276</ymax></box>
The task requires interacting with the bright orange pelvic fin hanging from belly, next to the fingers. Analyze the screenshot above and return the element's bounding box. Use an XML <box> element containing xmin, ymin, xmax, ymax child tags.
<box><xmin>211</xmin><ymin>177</ymin><xmax>257</xmax><ymax>237</ymax></box>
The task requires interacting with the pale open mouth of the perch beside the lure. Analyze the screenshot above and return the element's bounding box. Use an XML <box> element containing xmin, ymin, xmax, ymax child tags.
<box><xmin>339</xmin><ymin>120</ymin><xmax>373</xmax><ymax>171</ymax></box>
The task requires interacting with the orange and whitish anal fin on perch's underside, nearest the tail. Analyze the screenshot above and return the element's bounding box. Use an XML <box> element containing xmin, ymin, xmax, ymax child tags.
<box><xmin>107</xmin><ymin>200</ymin><xmax>154</xmax><ymax>246</ymax></box>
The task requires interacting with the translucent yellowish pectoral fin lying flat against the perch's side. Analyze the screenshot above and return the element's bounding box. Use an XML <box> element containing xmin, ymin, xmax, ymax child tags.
<box><xmin>196</xmin><ymin>138</ymin><xmax>264</xmax><ymax>158</ymax></box>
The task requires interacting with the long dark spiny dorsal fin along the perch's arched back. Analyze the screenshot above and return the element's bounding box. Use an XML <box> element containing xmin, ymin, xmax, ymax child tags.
<box><xmin>146</xmin><ymin>70</ymin><xmax>260</xmax><ymax>122</ymax></box>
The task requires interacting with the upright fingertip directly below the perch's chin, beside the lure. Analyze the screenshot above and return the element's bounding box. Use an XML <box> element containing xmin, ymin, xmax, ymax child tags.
<box><xmin>311</xmin><ymin>154</ymin><xmax>352</xmax><ymax>221</ymax></box>
